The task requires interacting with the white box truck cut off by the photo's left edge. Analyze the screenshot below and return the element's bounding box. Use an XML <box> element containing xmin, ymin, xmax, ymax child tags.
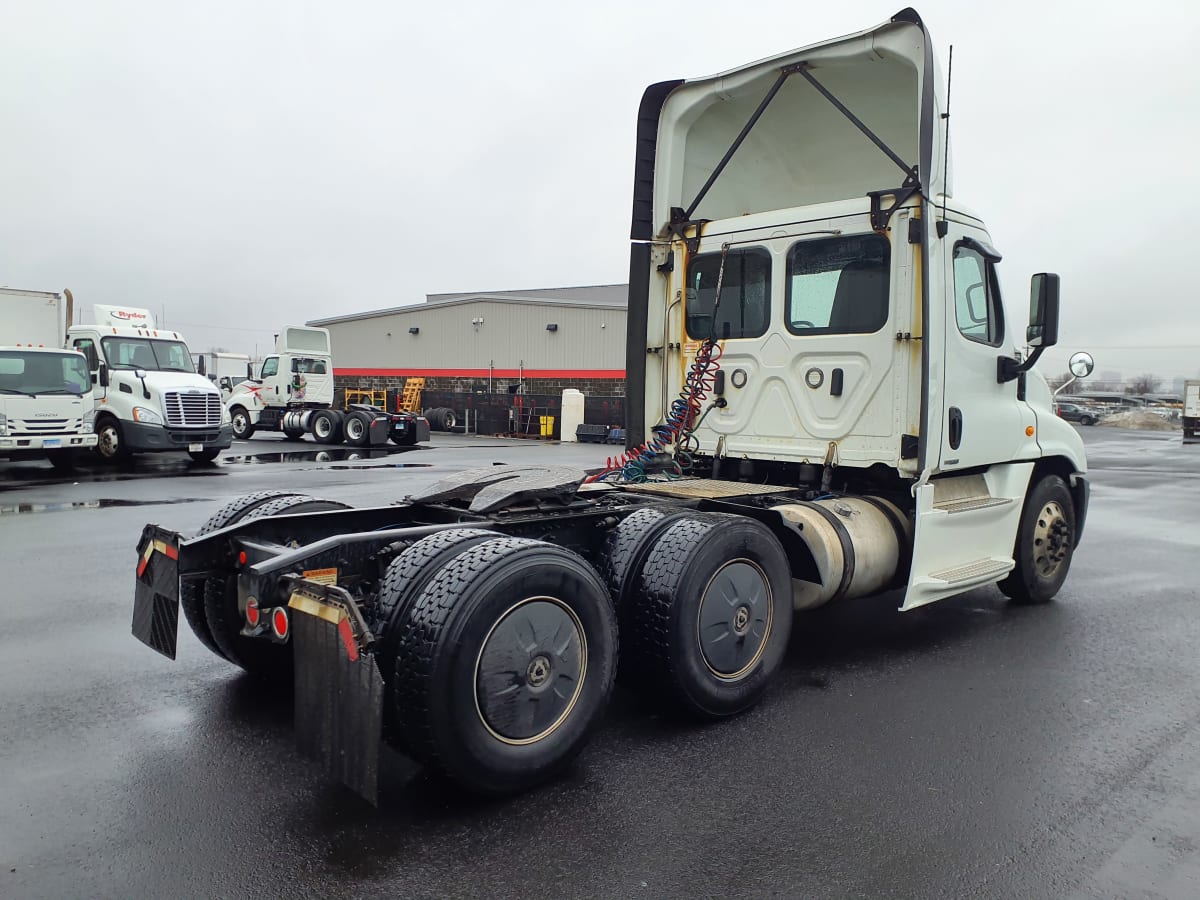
<box><xmin>0</xmin><ymin>288</ymin><xmax>96</xmax><ymax>469</ymax></box>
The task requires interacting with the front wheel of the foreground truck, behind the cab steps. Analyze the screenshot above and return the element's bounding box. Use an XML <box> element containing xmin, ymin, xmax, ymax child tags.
<box><xmin>1000</xmin><ymin>475</ymin><xmax>1075</xmax><ymax>605</ymax></box>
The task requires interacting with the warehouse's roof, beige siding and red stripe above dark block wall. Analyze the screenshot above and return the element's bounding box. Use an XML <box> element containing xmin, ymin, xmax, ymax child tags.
<box><xmin>308</xmin><ymin>284</ymin><xmax>628</xmax><ymax>397</ymax></box>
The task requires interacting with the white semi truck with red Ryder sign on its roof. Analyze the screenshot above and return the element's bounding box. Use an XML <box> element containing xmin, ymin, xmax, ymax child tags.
<box><xmin>67</xmin><ymin>304</ymin><xmax>233</xmax><ymax>461</ymax></box>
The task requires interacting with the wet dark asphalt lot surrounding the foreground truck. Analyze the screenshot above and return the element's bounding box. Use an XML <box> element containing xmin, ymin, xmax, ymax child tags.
<box><xmin>0</xmin><ymin>428</ymin><xmax>1200</xmax><ymax>899</ymax></box>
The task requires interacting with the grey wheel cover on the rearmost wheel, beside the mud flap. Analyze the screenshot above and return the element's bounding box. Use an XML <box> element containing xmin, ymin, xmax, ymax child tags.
<box><xmin>475</xmin><ymin>596</ymin><xmax>588</xmax><ymax>746</ymax></box>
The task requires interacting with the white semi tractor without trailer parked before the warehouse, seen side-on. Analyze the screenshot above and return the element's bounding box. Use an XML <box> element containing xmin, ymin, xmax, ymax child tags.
<box><xmin>226</xmin><ymin>325</ymin><xmax>430</xmax><ymax>446</ymax></box>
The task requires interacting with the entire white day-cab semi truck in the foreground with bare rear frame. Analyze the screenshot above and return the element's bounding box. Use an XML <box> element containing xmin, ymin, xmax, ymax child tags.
<box><xmin>133</xmin><ymin>10</ymin><xmax>1088</xmax><ymax>797</ymax></box>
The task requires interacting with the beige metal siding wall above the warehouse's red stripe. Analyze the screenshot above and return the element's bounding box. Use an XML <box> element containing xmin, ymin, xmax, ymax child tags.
<box><xmin>328</xmin><ymin>301</ymin><xmax>625</xmax><ymax>370</ymax></box>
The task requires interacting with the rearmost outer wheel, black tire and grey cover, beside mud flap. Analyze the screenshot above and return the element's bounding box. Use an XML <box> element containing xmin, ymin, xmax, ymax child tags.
<box><xmin>395</xmin><ymin>538</ymin><xmax>617</xmax><ymax>794</ymax></box>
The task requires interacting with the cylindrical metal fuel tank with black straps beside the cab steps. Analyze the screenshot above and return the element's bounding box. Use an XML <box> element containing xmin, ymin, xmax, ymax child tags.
<box><xmin>774</xmin><ymin>497</ymin><xmax>912</xmax><ymax>610</ymax></box>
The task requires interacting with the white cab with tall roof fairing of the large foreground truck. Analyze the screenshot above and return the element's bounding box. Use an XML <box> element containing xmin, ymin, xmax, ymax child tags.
<box><xmin>628</xmin><ymin>10</ymin><xmax>1087</xmax><ymax>610</ymax></box>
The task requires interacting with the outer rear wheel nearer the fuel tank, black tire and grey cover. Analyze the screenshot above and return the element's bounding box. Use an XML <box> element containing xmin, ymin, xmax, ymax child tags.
<box><xmin>625</xmin><ymin>515</ymin><xmax>792</xmax><ymax>719</ymax></box>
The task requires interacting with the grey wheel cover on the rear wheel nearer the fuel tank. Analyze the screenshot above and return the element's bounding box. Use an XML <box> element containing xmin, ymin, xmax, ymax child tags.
<box><xmin>696</xmin><ymin>559</ymin><xmax>774</xmax><ymax>680</ymax></box>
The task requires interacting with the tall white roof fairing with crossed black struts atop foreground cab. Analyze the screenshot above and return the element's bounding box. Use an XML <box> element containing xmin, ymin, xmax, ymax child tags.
<box><xmin>632</xmin><ymin>10</ymin><xmax>947</xmax><ymax>232</ymax></box>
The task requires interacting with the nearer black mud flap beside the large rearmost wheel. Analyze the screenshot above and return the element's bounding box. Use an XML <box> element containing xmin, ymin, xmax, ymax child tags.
<box><xmin>288</xmin><ymin>586</ymin><xmax>384</xmax><ymax>804</ymax></box>
